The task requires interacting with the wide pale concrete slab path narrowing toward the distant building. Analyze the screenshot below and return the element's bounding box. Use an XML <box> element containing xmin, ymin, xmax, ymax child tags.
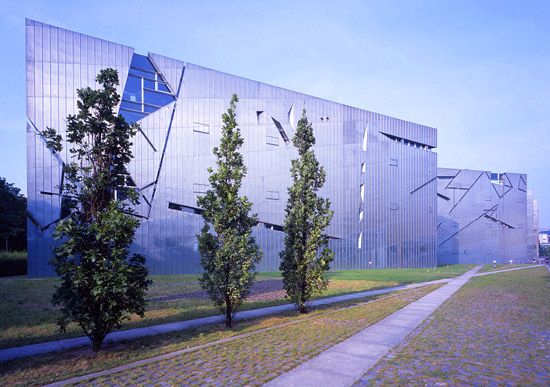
<box><xmin>265</xmin><ymin>265</ymin><xmax>482</xmax><ymax>387</ymax></box>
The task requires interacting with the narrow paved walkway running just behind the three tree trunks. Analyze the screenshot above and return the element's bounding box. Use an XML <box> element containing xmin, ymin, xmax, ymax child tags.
<box><xmin>0</xmin><ymin>265</ymin><xmax>540</xmax><ymax>361</ymax></box>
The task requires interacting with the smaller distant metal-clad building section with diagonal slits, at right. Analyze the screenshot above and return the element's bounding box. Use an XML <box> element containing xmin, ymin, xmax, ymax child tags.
<box><xmin>437</xmin><ymin>168</ymin><xmax>538</xmax><ymax>264</ymax></box>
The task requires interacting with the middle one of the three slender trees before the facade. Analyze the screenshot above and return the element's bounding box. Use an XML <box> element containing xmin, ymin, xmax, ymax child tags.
<box><xmin>197</xmin><ymin>94</ymin><xmax>262</xmax><ymax>328</ymax></box>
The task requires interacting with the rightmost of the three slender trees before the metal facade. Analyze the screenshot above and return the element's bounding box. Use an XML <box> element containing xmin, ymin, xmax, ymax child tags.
<box><xmin>279</xmin><ymin>109</ymin><xmax>334</xmax><ymax>313</ymax></box>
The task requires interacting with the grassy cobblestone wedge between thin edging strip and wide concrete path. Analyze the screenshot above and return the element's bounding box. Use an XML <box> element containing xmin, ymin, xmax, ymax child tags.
<box><xmin>73</xmin><ymin>287</ymin><xmax>434</xmax><ymax>386</ymax></box>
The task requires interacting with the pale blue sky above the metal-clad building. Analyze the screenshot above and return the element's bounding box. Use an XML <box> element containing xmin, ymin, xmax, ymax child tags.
<box><xmin>0</xmin><ymin>0</ymin><xmax>550</xmax><ymax>227</ymax></box>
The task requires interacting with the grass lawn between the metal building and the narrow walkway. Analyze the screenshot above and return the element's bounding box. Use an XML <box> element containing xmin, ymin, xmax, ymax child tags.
<box><xmin>0</xmin><ymin>265</ymin><xmax>469</xmax><ymax>348</ymax></box>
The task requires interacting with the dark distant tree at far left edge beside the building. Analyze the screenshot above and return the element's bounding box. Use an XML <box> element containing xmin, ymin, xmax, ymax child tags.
<box><xmin>0</xmin><ymin>177</ymin><xmax>27</xmax><ymax>251</ymax></box>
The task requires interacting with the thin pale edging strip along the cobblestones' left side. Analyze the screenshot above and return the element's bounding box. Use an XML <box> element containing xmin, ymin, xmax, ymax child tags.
<box><xmin>43</xmin><ymin>285</ymin><xmax>440</xmax><ymax>387</ymax></box>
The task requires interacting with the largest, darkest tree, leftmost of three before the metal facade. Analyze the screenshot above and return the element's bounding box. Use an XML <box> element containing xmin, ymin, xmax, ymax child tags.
<box><xmin>44</xmin><ymin>69</ymin><xmax>149</xmax><ymax>352</ymax></box>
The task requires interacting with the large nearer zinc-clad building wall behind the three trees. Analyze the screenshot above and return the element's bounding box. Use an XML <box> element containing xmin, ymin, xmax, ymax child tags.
<box><xmin>26</xmin><ymin>20</ymin><xmax>437</xmax><ymax>276</ymax></box>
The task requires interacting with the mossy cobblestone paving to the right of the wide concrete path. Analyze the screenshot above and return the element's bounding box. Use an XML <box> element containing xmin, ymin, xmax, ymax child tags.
<box><xmin>355</xmin><ymin>268</ymin><xmax>550</xmax><ymax>386</ymax></box>
